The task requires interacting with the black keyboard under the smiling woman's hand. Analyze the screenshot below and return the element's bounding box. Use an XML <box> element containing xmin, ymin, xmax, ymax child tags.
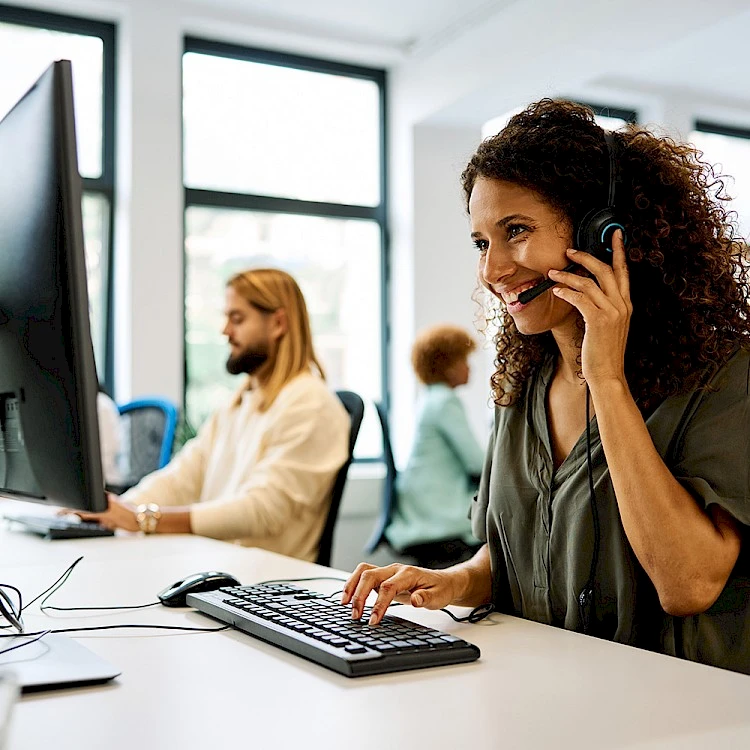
<box><xmin>187</xmin><ymin>583</ymin><xmax>479</xmax><ymax>677</ymax></box>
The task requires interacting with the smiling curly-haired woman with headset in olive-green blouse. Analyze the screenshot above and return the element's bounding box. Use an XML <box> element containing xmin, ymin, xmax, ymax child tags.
<box><xmin>342</xmin><ymin>100</ymin><xmax>750</xmax><ymax>673</ymax></box>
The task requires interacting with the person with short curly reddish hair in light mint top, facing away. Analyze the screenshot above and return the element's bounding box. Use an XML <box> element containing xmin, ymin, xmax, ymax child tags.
<box><xmin>385</xmin><ymin>325</ymin><xmax>484</xmax><ymax>568</ymax></box>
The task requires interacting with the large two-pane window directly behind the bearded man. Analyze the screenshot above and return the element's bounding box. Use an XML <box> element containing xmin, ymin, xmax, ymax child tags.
<box><xmin>183</xmin><ymin>39</ymin><xmax>386</xmax><ymax>459</ymax></box>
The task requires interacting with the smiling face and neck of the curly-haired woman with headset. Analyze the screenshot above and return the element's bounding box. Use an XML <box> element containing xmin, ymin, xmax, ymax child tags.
<box><xmin>469</xmin><ymin>177</ymin><xmax>578</xmax><ymax>334</ymax></box>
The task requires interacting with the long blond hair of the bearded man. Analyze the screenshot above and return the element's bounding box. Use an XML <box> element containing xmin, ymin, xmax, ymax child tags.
<box><xmin>227</xmin><ymin>268</ymin><xmax>325</xmax><ymax>411</ymax></box>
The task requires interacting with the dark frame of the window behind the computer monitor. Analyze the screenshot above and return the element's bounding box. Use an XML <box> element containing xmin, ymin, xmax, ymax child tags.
<box><xmin>0</xmin><ymin>4</ymin><xmax>117</xmax><ymax>393</ymax></box>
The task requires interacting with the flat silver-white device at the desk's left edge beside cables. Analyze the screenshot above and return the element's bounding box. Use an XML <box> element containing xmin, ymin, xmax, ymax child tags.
<box><xmin>0</xmin><ymin>633</ymin><xmax>120</xmax><ymax>692</ymax></box>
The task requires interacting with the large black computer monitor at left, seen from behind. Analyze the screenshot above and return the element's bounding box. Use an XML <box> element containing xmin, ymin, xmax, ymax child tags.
<box><xmin>0</xmin><ymin>60</ymin><xmax>107</xmax><ymax>511</ymax></box>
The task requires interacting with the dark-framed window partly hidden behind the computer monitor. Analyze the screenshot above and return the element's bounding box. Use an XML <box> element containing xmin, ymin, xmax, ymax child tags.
<box><xmin>0</xmin><ymin>6</ymin><xmax>115</xmax><ymax>388</ymax></box>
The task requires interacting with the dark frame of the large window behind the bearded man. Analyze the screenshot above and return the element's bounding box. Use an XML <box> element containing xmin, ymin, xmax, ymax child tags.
<box><xmin>182</xmin><ymin>36</ymin><xmax>390</xmax><ymax>463</ymax></box>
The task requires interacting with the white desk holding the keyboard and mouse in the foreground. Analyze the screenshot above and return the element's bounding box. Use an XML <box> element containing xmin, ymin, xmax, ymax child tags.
<box><xmin>0</xmin><ymin>506</ymin><xmax>750</xmax><ymax>750</ymax></box>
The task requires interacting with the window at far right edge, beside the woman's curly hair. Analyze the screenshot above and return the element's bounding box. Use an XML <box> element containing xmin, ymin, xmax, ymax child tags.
<box><xmin>690</xmin><ymin>120</ymin><xmax>750</xmax><ymax>237</ymax></box>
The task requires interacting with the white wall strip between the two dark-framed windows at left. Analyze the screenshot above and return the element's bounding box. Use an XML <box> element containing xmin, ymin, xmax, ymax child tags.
<box><xmin>114</xmin><ymin>2</ymin><xmax>184</xmax><ymax>403</ymax></box>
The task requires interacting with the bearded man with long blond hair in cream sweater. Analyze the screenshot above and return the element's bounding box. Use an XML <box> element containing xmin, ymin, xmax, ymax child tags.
<box><xmin>77</xmin><ymin>268</ymin><xmax>350</xmax><ymax>560</ymax></box>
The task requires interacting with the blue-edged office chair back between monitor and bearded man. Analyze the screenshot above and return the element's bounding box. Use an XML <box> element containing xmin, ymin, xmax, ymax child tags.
<box><xmin>113</xmin><ymin>398</ymin><xmax>178</xmax><ymax>492</ymax></box>
